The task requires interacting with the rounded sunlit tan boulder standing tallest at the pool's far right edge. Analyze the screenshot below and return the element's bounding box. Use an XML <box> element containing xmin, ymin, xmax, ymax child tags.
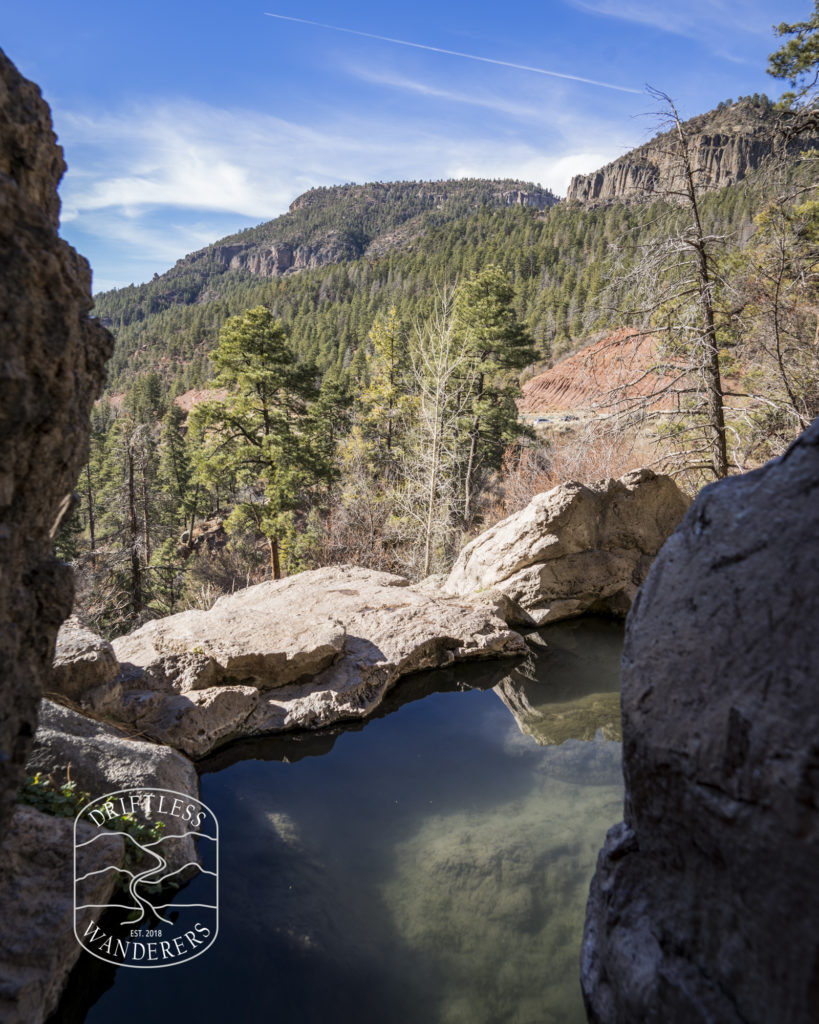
<box><xmin>444</xmin><ymin>469</ymin><xmax>688</xmax><ymax>625</ymax></box>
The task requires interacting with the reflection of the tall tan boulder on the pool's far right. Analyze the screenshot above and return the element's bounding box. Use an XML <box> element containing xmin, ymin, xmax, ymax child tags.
<box><xmin>494</xmin><ymin>676</ymin><xmax>622</xmax><ymax>746</ymax></box>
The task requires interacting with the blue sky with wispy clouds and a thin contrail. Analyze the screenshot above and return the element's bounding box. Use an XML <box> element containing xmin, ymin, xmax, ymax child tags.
<box><xmin>0</xmin><ymin>0</ymin><xmax>811</xmax><ymax>291</ymax></box>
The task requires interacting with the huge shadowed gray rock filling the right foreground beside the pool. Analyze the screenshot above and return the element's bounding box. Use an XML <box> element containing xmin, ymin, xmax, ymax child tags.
<box><xmin>581</xmin><ymin>420</ymin><xmax>819</xmax><ymax>1024</ymax></box>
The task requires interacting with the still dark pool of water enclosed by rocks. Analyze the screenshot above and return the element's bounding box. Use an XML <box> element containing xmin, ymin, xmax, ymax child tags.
<box><xmin>67</xmin><ymin>620</ymin><xmax>622</xmax><ymax>1024</ymax></box>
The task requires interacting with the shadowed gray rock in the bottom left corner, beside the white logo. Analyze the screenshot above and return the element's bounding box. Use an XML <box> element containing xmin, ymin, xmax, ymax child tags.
<box><xmin>0</xmin><ymin>805</ymin><xmax>125</xmax><ymax>1024</ymax></box>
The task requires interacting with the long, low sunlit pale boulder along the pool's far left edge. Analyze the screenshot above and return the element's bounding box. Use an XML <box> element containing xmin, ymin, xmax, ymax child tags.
<box><xmin>113</xmin><ymin>566</ymin><xmax>525</xmax><ymax>757</ymax></box>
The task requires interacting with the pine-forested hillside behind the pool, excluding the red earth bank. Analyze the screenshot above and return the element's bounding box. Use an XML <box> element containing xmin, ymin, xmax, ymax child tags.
<box><xmin>65</xmin><ymin>88</ymin><xmax>819</xmax><ymax>634</ymax></box>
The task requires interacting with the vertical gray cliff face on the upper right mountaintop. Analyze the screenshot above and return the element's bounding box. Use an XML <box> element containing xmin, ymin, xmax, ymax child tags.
<box><xmin>566</xmin><ymin>100</ymin><xmax>773</xmax><ymax>206</ymax></box>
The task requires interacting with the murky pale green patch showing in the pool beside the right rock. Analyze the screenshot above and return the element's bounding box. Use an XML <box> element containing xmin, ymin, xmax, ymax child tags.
<box><xmin>384</xmin><ymin>770</ymin><xmax>621</xmax><ymax>1024</ymax></box>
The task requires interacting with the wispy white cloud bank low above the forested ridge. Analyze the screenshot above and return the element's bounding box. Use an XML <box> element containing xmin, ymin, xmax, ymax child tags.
<box><xmin>55</xmin><ymin>97</ymin><xmax>637</xmax><ymax>287</ymax></box>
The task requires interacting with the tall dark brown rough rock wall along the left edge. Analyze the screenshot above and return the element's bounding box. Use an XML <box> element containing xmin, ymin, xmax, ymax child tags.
<box><xmin>0</xmin><ymin>52</ymin><xmax>112</xmax><ymax>835</ymax></box>
